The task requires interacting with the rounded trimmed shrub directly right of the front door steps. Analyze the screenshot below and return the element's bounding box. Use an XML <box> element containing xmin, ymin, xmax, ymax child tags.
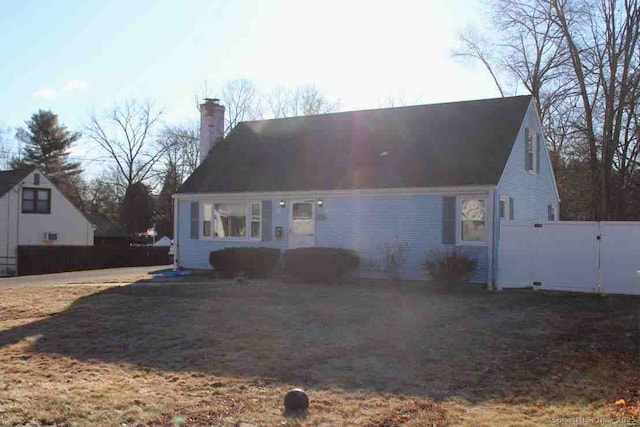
<box><xmin>284</xmin><ymin>248</ymin><xmax>360</xmax><ymax>281</ymax></box>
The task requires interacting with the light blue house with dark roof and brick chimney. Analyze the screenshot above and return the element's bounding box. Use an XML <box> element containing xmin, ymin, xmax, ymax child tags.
<box><xmin>174</xmin><ymin>96</ymin><xmax>559</xmax><ymax>283</ymax></box>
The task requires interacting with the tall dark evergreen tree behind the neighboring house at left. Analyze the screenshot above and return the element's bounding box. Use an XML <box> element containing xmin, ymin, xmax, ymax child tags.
<box><xmin>10</xmin><ymin>110</ymin><xmax>82</xmax><ymax>180</ymax></box>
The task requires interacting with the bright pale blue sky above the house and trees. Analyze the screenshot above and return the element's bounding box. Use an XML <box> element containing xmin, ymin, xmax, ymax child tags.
<box><xmin>0</xmin><ymin>0</ymin><xmax>499</xmax><ymax>167</ymax></box>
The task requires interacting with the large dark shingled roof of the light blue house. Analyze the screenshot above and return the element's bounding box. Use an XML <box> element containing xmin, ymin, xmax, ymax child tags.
<box><xmin>178</xmin><ymin>96</ymin><xmax>531</xmax><ymax>193</ymax></box>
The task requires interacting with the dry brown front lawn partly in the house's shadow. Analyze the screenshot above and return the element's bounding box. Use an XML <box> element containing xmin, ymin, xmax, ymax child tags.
<box><xmin>0</xmin><ymin>281</ymin><xmax>640</xmax><ymax>426</ymax></box>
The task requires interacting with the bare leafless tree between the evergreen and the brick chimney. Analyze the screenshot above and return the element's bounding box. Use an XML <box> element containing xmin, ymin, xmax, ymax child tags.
<box><xmin>85</xmin><ymin>101</ymin><xmax>164</xmax><ymax>188</ymax></box>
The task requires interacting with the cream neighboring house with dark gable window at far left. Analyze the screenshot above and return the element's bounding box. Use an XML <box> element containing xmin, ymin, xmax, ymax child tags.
<box><xmin>0</xmin><ymin>168</ymin><xmax>93</xmax><ymax>275</ymax></box>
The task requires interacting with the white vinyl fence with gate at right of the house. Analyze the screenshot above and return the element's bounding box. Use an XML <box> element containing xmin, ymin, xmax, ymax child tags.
<box><xmin>498</xmin><ymin>221</ymin><xmax>640</xmax><ymax>295</ymax></box>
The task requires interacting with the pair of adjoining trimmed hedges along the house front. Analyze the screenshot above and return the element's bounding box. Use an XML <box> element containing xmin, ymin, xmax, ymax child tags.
<box><xmin>209</xmin><ymin>247</ymin><xmax>360</xmax><ymax>281</ymax></box>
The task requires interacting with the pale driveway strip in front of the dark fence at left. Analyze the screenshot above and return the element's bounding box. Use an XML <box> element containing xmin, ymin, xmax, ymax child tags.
<box><xmin>0</xmin><ymin>265</ymin><xmax>172</xmax><ymax>289</ymax></box>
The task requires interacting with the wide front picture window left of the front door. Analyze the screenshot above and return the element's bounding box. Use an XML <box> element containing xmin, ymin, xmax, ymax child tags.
<box><xmin>201</xmin><ymin>202</ymin><xmax>262</xmax><ymax>240</ymax></box>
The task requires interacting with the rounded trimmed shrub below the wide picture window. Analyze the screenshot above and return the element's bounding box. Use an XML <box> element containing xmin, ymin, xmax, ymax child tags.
<box><xmin>209</xmin><ymin>248</ymin><xmax>280</xmax><ymax>278</ymax></box>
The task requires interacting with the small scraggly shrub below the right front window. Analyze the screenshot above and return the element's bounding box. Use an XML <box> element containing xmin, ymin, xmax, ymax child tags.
<box><xmin>424</xmin><ymin>248</ymin><xmax>477</xmax><ymax>284</ymax></box>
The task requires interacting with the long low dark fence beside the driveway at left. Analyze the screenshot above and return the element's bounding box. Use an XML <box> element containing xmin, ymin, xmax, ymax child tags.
<box><xmin>18</xmin><ymin>246</ymin><xmax>172</xmax><ymax>276</ymax></box>
